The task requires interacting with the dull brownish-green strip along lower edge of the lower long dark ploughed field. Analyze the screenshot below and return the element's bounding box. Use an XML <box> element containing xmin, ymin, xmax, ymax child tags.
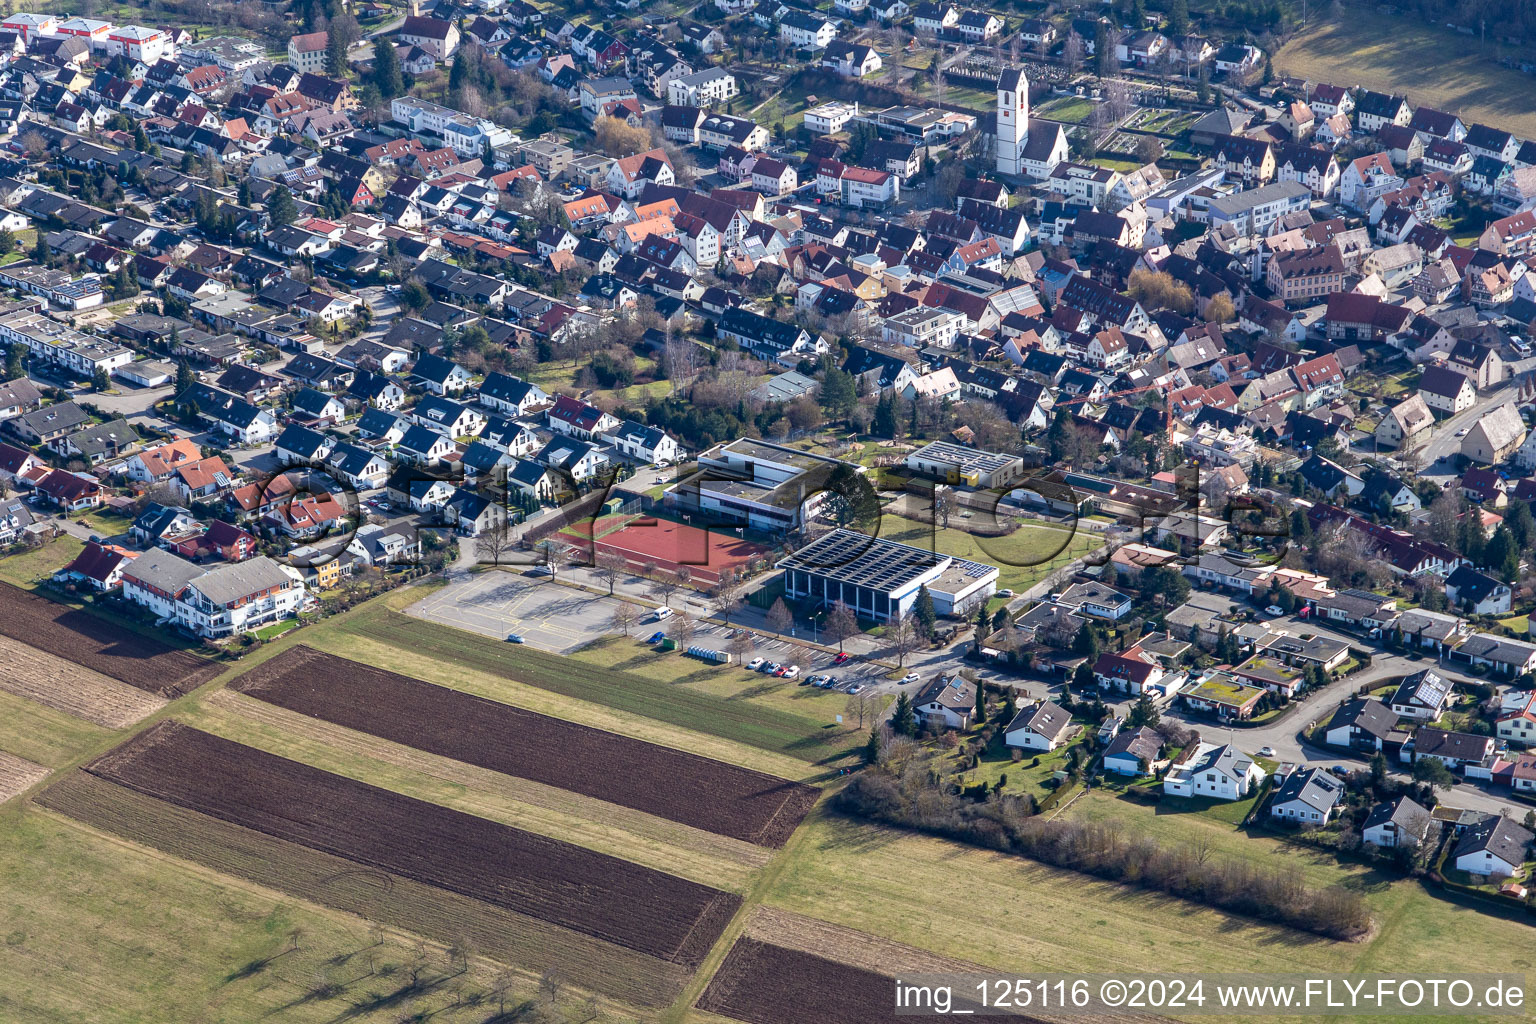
<box><xmin>38</xmin><ymin>771</ymin><xmax>687</xmax><ymax>1007</ymax></box>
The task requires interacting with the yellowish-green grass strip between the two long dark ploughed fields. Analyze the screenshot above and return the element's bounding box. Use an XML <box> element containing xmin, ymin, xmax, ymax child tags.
<box><xmin>195</xmin><ymin>689</ymin><xmax>773</xmax><ymax>892</ymax></box>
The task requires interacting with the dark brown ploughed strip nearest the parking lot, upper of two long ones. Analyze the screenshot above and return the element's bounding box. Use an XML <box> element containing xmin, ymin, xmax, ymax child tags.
<box><xmin>232</xmin><ymin>646</ymin><xmax>820</xmax><ymax>847</ymax></box>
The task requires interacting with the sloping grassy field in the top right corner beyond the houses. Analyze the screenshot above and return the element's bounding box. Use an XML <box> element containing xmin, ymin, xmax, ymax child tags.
<box><xmin>1275</xmin><ymin>15</ymin><xmax>1536</xmax><ymax>138</ymax></box>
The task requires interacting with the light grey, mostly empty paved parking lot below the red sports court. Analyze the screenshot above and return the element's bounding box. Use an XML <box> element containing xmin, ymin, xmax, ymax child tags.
<box><xmin>406</xmin><ymin>570</ymin><xmax>629</xmax><ymax>654</ymax></box>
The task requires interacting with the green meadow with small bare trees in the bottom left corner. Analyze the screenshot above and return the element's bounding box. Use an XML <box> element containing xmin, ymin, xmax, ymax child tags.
<box><xmin>0</xmin><ymin>806</ymin><xmax>571</xmax><ymax>1024</ymax></box>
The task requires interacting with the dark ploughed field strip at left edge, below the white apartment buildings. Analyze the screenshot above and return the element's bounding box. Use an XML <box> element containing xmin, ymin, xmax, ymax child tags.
<box><xmin>0</xmin><ymin>583</ymin><xmax>223</xmax><ymax>697</ymax></box>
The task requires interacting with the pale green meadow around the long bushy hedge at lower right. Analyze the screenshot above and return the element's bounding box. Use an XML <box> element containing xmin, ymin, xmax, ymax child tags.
<box><xmin>765</xmin><ymin>810</ymin><xmax>1536</xmax><ymax>1021</ymax></box>
